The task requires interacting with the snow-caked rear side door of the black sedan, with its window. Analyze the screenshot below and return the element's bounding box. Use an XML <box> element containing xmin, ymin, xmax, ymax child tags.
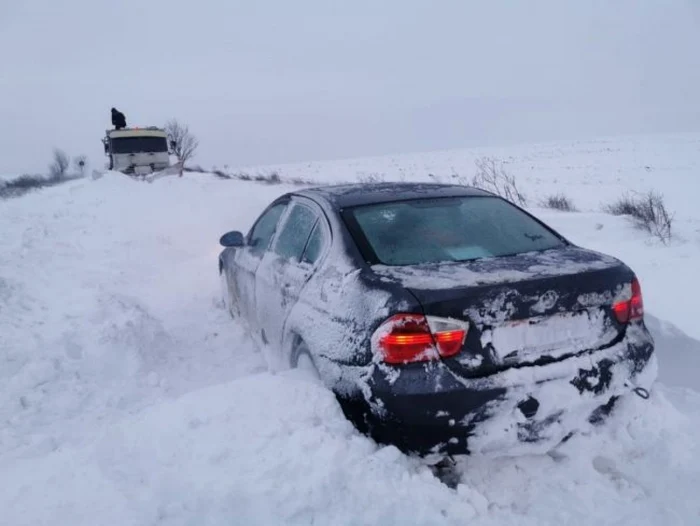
<box><xmin>255</xmin><ymin>199</ymin><xmax>321</xmax><ymax>358</ymax></box>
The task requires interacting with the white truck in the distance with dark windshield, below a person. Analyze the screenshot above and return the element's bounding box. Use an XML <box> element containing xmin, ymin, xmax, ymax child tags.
<box><xmin>102</xmin><ymin>126</ymin><xmax>170</xmax><ymax>175</ymax></box>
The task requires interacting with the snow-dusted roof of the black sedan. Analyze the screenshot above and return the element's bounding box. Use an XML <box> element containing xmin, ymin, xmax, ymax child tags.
<box><xmin>294</xmin><ymin>182</ymin><xmax>493</xmax><ymax>208</ymax></box>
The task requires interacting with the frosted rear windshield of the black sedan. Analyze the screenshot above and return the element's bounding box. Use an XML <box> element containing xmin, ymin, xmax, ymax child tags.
<box><xmin>345</xmin><ymin>197</ymin><xmax>565</xmax><ymax>265</ymax></box>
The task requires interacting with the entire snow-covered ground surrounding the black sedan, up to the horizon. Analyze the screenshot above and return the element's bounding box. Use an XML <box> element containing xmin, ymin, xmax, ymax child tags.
<box><xmin>0</xmin><ymin>135</ymin><xmax>700</xmax><ymax>526</ymax></box>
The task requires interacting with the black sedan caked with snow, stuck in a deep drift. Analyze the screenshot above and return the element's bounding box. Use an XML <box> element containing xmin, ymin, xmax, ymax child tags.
<box><xmin>219</xmin><ymin>183</ymin><xmax>657</xmax><ymax>454</ymax></box>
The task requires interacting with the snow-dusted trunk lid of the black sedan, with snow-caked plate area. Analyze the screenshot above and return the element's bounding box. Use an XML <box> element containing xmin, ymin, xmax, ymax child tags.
<box><xmin>375</xmin><ymin>246</ymin><xmax>633</xmax><ymax>377</ymax></box>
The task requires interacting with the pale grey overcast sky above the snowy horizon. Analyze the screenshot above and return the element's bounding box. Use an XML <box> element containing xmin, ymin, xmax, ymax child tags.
<box><xmin>0</xmin><ymin>0</ymin><xmax>700</xmax><ymax>173</ymax></box>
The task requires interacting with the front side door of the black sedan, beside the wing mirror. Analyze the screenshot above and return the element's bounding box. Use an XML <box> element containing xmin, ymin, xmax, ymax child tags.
<box><xmin>227</xmin><ymin>199</ymin><xmax>289</xmax><ymax>328</ymax></box>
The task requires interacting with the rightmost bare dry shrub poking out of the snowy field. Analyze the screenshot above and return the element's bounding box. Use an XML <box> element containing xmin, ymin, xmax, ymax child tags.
<box><xmin>603</xmin><ymin>190</ymin><xmax>673</xmax><ymax>244</ymax></box>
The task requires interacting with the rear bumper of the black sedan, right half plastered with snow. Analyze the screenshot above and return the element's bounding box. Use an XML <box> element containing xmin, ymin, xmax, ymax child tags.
<box><xmin>369</xmin><ymin>324</ymin><xmax>657</xmax><ymax>454</ymax></box>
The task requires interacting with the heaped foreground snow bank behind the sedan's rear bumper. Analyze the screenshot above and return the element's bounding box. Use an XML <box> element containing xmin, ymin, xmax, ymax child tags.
<box><xmin>3</xmin><ymin>373</ymin><xmax>700</xmax><ymax>526</ymax></box>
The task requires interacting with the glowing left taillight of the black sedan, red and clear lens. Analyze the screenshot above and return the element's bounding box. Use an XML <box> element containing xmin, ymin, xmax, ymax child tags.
<box><xmin>372</xmin><ymin>314</ymin><xmax>469</xmax><ymax>364</ymax></box>
